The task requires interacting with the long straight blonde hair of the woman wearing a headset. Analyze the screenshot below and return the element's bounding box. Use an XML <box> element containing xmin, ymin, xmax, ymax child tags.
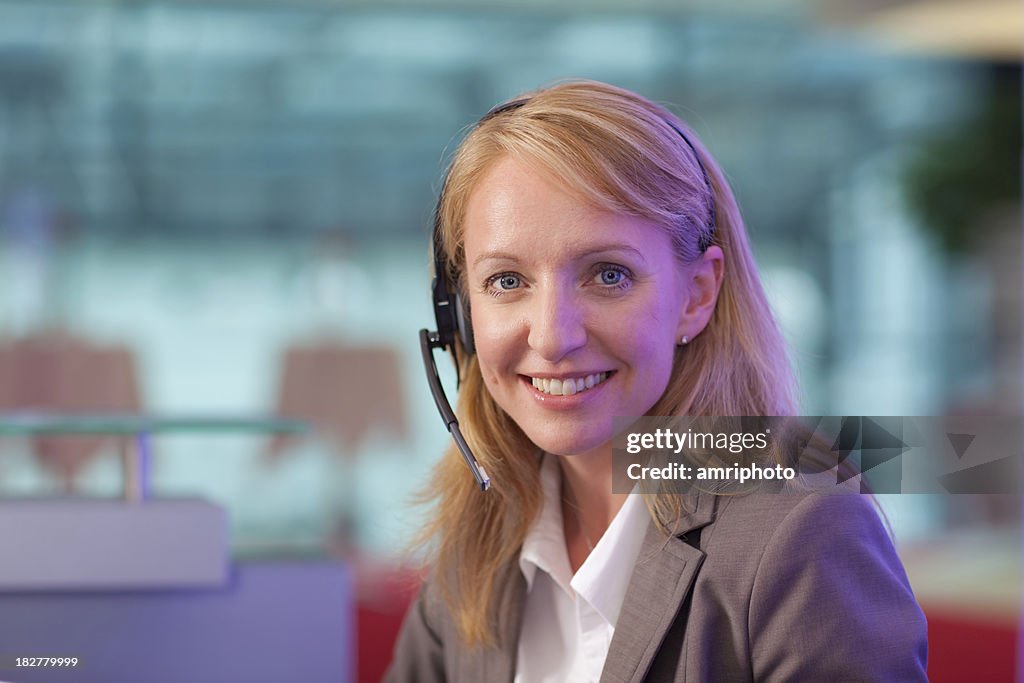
<box><xmin>411</xmin><ymin>81</ymin><xmax>795</xmax><ymax>646</ymax></box>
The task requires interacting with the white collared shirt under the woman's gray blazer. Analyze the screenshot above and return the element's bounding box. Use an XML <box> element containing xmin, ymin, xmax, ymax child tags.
<box><xmin>515</xmin><ymin>455</ymin><xmax>650</xmax><ymax>683</ymax></box>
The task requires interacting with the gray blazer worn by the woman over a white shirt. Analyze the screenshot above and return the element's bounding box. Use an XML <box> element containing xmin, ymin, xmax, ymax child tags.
<box><xmin>385</xmin><ymin>494</ymin><xmax>928</xmax><ymax>683</ymax></box>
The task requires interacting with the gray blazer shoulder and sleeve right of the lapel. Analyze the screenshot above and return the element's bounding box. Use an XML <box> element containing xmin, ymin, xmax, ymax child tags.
<box><xmin>707</xmin><ymin>494</ymin><xmax>927</xmax><ymax>680</ymax></box>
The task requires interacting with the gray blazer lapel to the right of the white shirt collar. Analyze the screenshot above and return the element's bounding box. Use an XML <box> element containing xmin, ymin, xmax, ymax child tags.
<box><xmin>601</xmin><ymin>493</ymin><xmax>717</xmax><ymax>683</ymax></box>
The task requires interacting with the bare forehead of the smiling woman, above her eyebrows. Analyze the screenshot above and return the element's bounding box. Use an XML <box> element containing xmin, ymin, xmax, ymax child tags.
<box><xmin>463</xmin><ymin>157</ymin><xmax>672</xmax><ymax>268</ymax></box>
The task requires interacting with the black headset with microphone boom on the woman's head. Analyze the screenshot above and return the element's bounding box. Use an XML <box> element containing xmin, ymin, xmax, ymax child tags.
<box><xmin>420</xmin><ymin>97</ymin><xmax>716</xmax><ymax>490</ymax></box>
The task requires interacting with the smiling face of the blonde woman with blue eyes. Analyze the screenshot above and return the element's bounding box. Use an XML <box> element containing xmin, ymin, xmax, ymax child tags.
<box><xmin>465</xmin><ymin>158</ymin><xmax>689</xmax><ymax>455</ymax></box>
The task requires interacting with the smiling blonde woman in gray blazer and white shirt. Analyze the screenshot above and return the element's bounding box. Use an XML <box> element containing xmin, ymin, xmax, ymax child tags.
<box><xmin>388</xmin><ymin>82</ymin><xmax>927</xmax><ymax>682</ymax></box>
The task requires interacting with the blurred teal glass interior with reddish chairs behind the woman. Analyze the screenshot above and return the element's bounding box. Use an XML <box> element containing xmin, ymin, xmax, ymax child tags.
<box><xmin>0</xmin><ymin>0</ymin><xmax>1024</xmax><ymax>681</ymax></box>
